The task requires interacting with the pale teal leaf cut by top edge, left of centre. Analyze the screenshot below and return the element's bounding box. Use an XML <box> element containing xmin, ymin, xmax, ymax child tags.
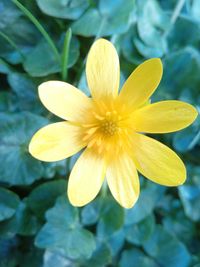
<box><xmin>37</xmin><ymin>0</ymin><xmax>88</xmax><ymax>19</ymax></box>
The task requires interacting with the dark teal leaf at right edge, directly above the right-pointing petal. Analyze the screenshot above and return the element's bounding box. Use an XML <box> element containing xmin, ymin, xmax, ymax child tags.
<box><xmin>161</xmin><ymin>47</ymin><xmax>200</xmax><ymax>103</ymax></box>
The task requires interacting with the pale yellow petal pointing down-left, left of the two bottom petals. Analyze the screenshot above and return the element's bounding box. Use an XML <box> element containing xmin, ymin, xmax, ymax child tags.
<box><xmin>68</xmin><ymin>149</ymin><xmax>105</xmax><ymax>207</ymax></box>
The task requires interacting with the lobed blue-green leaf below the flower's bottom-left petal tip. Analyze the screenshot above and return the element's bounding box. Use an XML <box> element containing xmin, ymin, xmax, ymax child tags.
<box><xmin>35</xmin><ymin>195</ymin><xmax>95</xmax><ymax>259</ymax></box>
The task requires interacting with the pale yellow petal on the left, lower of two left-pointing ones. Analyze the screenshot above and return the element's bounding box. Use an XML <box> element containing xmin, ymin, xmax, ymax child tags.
<box><xmin>29</xmin><ymin>122</ymin><xmax>85</xmax><ymax>162</ymax></box>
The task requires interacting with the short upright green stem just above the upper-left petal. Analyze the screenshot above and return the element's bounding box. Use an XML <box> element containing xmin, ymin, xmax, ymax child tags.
<box><xmin>62</xmin><ymin>28</ymin><xmax>72</xmax><ymax>81</ymax></box>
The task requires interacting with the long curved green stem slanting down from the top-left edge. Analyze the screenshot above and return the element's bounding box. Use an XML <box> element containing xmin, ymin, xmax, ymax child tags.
<box><xmin>12</xmin><ymin>0</ymin><xmax>60</xmax><ymax>62</ymax></box>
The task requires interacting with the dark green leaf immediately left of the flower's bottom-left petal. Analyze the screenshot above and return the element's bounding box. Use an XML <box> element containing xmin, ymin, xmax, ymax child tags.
<box><xmin>27</xmin><ymin>180</ymin><xmax>67</xmax><ymax>219</ymax></box>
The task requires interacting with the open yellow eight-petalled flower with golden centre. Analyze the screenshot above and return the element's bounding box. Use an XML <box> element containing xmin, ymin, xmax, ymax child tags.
<box><xmin>29</xmin><ymin>39</ymin><xmax>197</xmax><ymax>208</ymax></box>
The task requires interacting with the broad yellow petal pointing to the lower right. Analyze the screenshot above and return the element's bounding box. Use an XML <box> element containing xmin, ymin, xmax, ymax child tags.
<box><xmin>132</xmin><ymin>133</ymin><xmax>186</xmax><ymax>186</ymax></box>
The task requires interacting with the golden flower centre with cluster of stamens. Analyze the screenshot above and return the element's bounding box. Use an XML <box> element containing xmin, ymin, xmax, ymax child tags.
<box><xmin>83</xmin><ymin>103</ymin><xmax>127</xmax><ymax>154</ymax></box>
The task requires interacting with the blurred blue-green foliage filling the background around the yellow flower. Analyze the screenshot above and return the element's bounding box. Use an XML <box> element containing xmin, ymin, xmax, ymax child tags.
<box><xmin>0</xmin><ymin>0</ymin><xmax>200</xmax><ymax>267</ymax></box>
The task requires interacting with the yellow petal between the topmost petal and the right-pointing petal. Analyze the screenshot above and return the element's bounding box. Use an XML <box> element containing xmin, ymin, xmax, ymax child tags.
<box><xmin>119</xmin><ymin>58</ymin><xmax>163</xmax><ymax>108</ymax></box>
